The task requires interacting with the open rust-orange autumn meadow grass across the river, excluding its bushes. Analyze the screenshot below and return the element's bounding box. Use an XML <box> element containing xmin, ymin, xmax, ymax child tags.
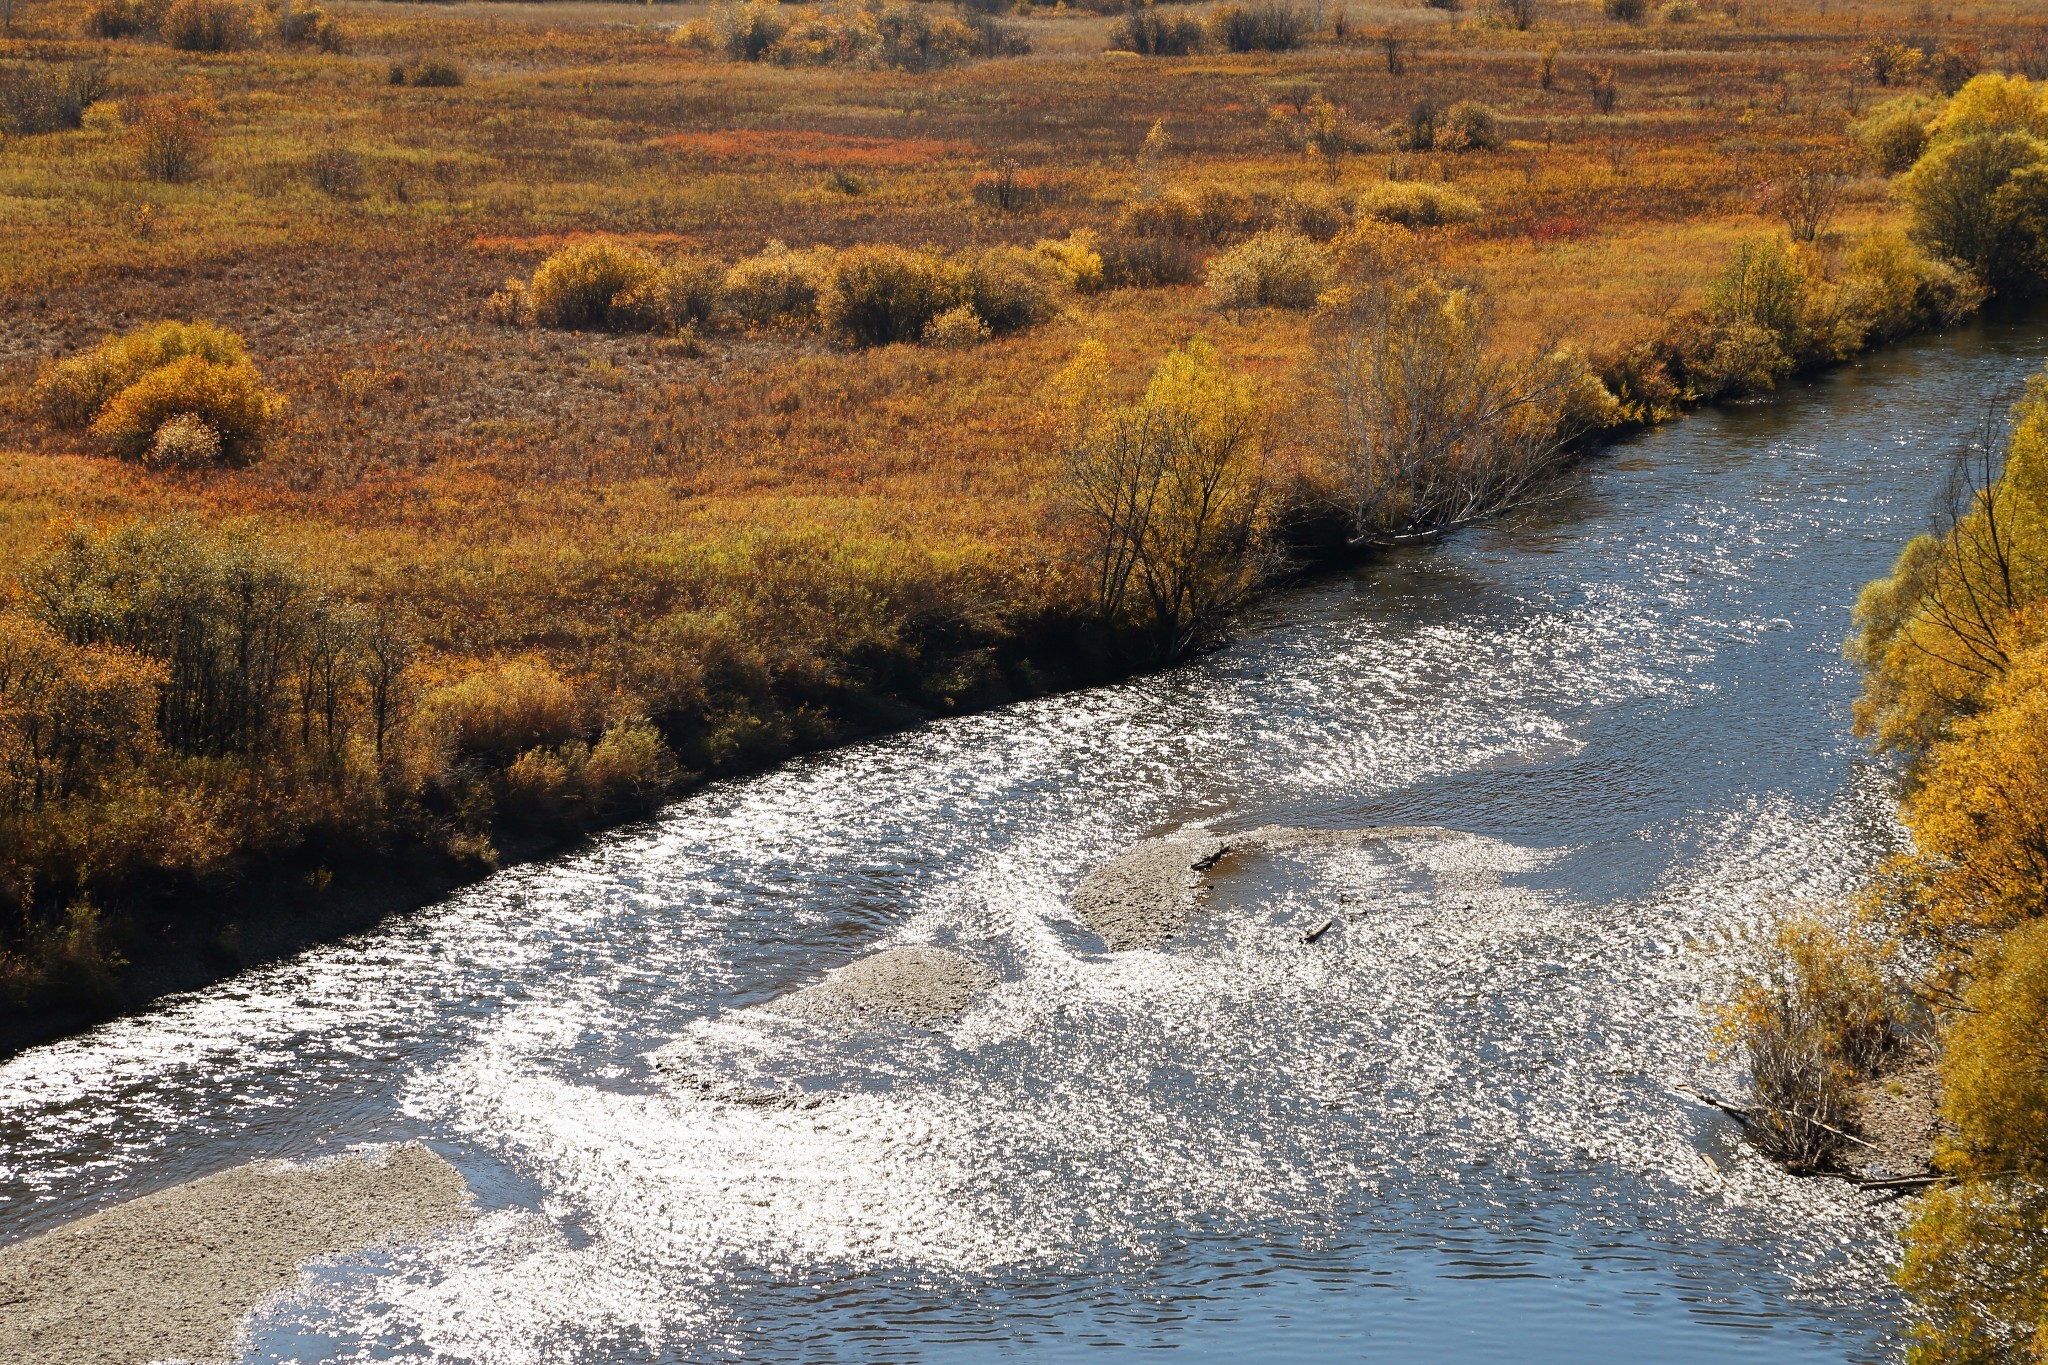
<box><xmin>0</xmin><ymin>0</ymin><xmax>2048</xmax><ymax>1023</ymax></box>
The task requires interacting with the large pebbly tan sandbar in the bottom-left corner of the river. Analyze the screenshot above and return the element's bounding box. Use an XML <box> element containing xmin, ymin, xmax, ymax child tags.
<box><xmin>0</xmin><ymin>1146</ymin><xmax>469</xmax><ymax>1365</ymax></box>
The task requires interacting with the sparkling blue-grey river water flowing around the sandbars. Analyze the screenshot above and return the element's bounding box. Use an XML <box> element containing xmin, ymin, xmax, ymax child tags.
<box><xmin>0</xmin><ymin>313</ymin><xmax>2048</xmax><ymax>1365</ymax></box>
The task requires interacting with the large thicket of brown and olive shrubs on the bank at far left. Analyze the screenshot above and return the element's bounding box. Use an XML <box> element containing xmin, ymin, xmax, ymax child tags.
<box><xmin>0</xmin><ymin>524</ymin><xmax>676</xmax><ymax>1009</ymax></box>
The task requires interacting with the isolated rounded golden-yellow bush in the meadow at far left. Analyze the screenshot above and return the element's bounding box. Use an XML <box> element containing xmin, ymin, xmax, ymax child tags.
<box><xmin>35</xmin><ymin>321</ymin><xmax>285</xmax><ymax>467</ymax></box>
